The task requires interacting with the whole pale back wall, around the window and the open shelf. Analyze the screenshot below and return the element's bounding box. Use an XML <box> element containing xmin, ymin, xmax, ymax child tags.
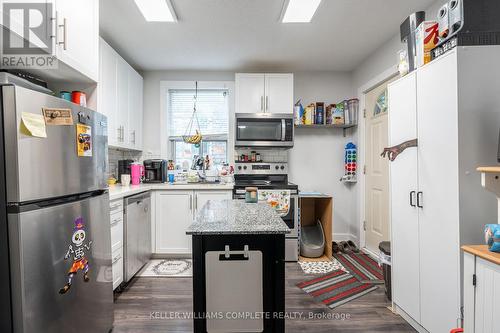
<box><xmin>142</xmin><ymin>71</ymin><xmax>356</xmax><ymax>238</ymax></box>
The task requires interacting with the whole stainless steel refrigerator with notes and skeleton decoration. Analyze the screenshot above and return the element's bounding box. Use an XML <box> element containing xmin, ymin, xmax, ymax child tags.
<box><xmin>0</xmin><ymin>84</ymin><xmax>113</xmax><ymax>333</ymax></box>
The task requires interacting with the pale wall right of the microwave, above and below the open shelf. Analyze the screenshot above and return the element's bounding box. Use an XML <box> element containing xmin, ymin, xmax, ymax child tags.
<box><xmin>289</xmin><ymin>72</ymin><xmax>357</xmax><ymax>240</ymax></box>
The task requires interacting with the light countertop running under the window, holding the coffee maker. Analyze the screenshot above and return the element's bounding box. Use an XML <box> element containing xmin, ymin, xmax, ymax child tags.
<box><xmin>109</xmin><ymin>183</ymin><xmax>233</xmax><ymax>200</ymax></box>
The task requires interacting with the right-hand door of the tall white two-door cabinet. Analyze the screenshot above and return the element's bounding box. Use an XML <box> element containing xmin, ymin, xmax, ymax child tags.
<box><xmin>417</xmin><ymin>52</ymin><xmax>460</xmax><ymax>332</ymax></box>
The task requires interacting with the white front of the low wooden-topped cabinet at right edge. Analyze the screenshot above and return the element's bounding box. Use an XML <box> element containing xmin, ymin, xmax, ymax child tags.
<box><xmin>464</xmin><ymin>253</ymin><xmax>500</xmax><ymax>333</ymax></box>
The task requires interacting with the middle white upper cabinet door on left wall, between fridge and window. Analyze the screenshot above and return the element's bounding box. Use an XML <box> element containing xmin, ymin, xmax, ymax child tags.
<box><xmin>116</xmin><ymin>57</ymin><xmax>130</xmax><ymax>147</ymax></box>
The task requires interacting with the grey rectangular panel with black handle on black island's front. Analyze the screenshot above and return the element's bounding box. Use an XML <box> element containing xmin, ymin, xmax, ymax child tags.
<box><xmin>205</xmin><ymin>251</ymin><xmax>264</xmax><ymax>333</ymax></box>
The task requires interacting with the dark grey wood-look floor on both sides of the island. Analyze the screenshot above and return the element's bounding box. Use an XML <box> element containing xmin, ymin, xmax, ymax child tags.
<box><xmin>113</xmin><ymin>263</ymin><xmax>415</xmax><ymax>333</ymax></box>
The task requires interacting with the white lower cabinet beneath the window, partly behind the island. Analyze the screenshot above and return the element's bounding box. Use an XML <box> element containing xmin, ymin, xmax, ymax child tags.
<box><xmin>153</xmin><ymin>190</ymin><xmax>232</xmax><ymax>254</ymax></box>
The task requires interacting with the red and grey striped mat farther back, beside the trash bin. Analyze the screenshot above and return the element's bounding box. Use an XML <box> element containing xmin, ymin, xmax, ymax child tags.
<box><xmin>334</xmin><ymin>253</ymin><xmax>384</xmax><ymax>283</ymax></box>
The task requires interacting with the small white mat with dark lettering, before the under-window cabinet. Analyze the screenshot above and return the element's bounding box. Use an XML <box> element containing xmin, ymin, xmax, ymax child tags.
<box><xmin>137</xmin><ymin>259</ymin><xmax>193</xmax><ymax>277</ymax></box>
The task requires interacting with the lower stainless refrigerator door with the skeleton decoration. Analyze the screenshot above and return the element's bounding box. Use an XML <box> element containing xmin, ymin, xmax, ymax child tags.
<box><xmin>8</xmin><ymin>193</ymin><xmax>113</xmax><ymax>333</ymax></box>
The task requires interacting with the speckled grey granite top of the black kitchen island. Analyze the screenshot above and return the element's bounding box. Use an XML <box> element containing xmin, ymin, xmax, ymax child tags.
<box><xmin>186</xmin><ymin>200</ymin><xmax>290</xmax><ymax>235</ymax></box>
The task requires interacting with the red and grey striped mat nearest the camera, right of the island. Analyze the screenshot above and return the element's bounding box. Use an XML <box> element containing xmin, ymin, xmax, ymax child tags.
<box><xmin>297</xmin><ymin>270</ymin><xmax>378</xmax><ymax>309</ymax></box>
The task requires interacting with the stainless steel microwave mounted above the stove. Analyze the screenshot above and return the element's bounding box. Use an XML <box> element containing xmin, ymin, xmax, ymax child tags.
<box><xmin>235</xmin><ymin>113</ymin><xmax>293</xmax><ymax>148</ymax></box>
